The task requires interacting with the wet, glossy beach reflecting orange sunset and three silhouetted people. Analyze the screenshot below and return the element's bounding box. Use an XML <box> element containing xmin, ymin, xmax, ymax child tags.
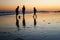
<box><xmin>0</xmin><ymin>12</ymin><xmax>60</xmax><ymax>40</ymax></box>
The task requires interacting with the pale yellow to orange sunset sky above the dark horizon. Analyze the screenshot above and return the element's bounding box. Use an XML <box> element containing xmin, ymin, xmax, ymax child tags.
<box><xmin>0</xmin><ymin>0</ymin><xmax>60</xmax><ymax>11</ymax></box>
